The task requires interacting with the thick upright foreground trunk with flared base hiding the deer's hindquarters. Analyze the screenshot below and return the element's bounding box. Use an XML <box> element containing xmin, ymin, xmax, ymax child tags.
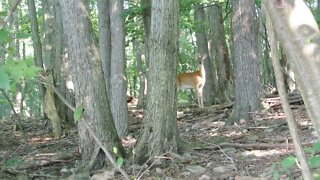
<box><xmin>136</xmin><ymin>0</ymin><xmax>179</xmax><ymax>163</ymax></box>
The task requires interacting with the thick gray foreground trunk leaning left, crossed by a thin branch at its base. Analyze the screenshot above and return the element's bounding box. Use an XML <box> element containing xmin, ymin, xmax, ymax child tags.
<box><xmin>60</xmin><ymin>0</ymin><xmax>124</xmax><ymax>168</ymax></box>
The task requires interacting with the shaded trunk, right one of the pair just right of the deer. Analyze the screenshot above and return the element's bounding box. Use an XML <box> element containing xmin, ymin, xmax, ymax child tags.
<box><xmin>208</xmin><ymin>3</ymin><xmax>231</xmax><ymax>102</ymax></box>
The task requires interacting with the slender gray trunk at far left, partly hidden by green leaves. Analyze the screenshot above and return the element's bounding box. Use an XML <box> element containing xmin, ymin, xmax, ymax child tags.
<box><xmin>27</xmin><ymin>0</ymin><xmax>45</xmax><ymax>105</ymax></box>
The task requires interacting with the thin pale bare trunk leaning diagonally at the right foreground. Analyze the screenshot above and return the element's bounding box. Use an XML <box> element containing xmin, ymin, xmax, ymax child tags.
<box><xmin>266</xmin><ymin>6</ymin><xmax>313</xmax><ymax>180</ymax></box>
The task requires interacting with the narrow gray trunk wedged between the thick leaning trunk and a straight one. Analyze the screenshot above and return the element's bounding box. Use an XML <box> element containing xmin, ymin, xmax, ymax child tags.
<box><xmin>97</xmin><ymin>0</ymin><xmax>111</xmax><ymax>97</ymax></box>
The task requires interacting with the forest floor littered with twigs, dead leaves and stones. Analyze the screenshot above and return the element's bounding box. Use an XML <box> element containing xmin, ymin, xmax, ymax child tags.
<box><xmin>0</xmin><ymin>93</ymin><xmax>316</xmax><ymax>180</ymax></box>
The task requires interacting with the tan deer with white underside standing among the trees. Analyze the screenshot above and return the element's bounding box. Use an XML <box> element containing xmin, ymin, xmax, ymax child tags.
<box><xmin>177</xmin><ymin>56</ymin><xmax>207</xmax><ymax>107</ymax></box>
